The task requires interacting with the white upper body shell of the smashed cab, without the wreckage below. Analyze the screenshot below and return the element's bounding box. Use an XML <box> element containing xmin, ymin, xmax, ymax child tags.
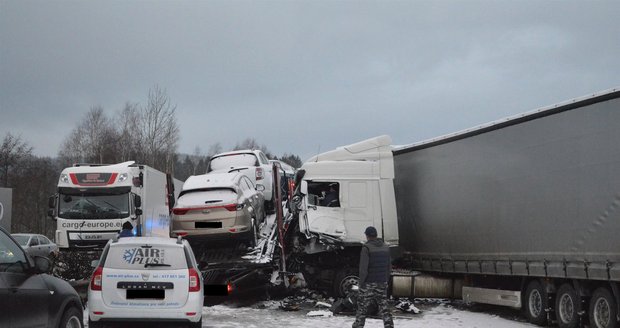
<box><xmin>298</xmin><ymin>136</ymin><xmax>398</xmax><ymax>253</ymax></box>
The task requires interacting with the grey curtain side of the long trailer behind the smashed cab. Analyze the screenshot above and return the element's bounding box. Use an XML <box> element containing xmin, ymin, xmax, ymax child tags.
<box><xmin>394</xmin><ymin>91</ymin><xmax>620</xmax><ymax>281</ymax></box>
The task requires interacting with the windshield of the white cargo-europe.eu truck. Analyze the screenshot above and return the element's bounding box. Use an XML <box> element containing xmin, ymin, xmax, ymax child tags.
<box><xmin>58</xmin><ymin>194</ymin><xmax>129</xmax><ymax>219</ymax></box>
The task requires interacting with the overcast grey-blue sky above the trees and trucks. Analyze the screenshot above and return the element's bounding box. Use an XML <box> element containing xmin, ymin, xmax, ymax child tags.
<box><xmin>0</xmin><ymin>0</ymin><xmax>620</xmax><ymax>159</ymax></box>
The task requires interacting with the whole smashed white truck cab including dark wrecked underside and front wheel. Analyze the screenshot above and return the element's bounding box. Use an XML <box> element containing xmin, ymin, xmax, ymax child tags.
<box><xmin>293</xmin><ymin>136</ymin><xmax>398</xmax><ymax>295</ymax></box>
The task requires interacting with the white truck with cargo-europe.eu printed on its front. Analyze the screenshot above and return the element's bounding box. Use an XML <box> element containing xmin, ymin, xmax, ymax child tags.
<box><xmin>48</xmin><ymin>161</ymin><xmax>183</xmax><ymax>249</ymax></box>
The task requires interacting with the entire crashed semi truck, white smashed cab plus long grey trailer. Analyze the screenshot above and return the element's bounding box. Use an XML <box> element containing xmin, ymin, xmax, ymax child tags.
<box><xmin>287</xmin><ymin>89</ymin><xmax>620</xmax><ymax>328</ymax></box>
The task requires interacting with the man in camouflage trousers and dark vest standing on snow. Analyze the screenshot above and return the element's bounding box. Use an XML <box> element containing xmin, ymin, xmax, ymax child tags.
<box><xmin>353</xmin><ymin>226</ymin><xmax>394</xmax><ymax>328</ymax></box>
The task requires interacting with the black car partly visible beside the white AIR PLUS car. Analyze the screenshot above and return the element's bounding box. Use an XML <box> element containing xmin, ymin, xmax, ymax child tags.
<box><xmin>0</xmin><ymin>228</ymin><xmax>84</xmax><ymax>328</ymax></box>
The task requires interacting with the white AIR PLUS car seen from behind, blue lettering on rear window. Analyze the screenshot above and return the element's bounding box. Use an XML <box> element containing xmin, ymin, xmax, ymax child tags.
<box><xmin>88</xmin><ymin>237</ymin><xmax>204</xmax><ymax>328</ymax></box>
